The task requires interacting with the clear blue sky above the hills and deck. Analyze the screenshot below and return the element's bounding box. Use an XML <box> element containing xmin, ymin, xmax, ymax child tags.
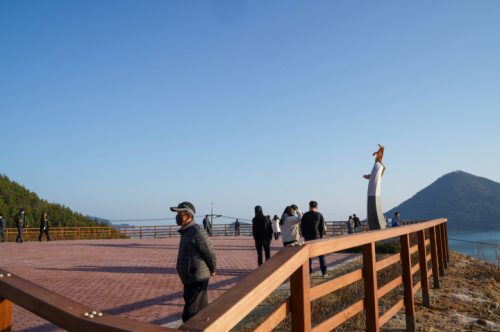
<box><xmin>0</xmin><ymin>0</ymin><xmax>500</xmax><ymax>225</ymax></box>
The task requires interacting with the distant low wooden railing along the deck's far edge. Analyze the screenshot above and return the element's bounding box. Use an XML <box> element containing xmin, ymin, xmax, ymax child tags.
<box><xmin>0</xmin><ymin>221</ymin><xmax>374</xmax><ymax>241</ymax></box>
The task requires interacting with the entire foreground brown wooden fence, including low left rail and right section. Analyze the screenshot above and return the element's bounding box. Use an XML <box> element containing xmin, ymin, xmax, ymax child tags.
<box><xmin>0</xmin><ymin>219</ymin><xmax>449</xmax><ymax>332</ymax></box>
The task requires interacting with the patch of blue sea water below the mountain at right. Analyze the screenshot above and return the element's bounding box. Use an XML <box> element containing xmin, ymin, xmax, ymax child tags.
<box><xmin>448</xmin><ymin>231</ymin><xmax>500</xmax><ymax>264</ymax></box>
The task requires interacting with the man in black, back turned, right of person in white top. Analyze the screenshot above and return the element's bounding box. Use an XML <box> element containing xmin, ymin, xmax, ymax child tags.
<box><xmin>300</xmin><ymin>201</ymin><xmax>328</xmax><ymax>277</ymax></box>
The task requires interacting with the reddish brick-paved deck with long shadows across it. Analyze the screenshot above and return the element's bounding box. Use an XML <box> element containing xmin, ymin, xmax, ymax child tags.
<box><xmin>0</xmin><ymin>236</ymin><xmax>353</xmax><ymax>332</ymax></box>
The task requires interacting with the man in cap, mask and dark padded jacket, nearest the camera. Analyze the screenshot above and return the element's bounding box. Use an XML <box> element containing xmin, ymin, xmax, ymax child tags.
<box><xmin>170</xmin><ymin>202</ymin><xmax>217</xmax><ymax>322</ymax></box>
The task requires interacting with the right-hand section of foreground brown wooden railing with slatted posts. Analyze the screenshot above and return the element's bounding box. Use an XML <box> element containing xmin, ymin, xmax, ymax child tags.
<box><xmin>180</xmin><ymin>219</ymin><xmax>449</xmax><ymax>332</ymax></box>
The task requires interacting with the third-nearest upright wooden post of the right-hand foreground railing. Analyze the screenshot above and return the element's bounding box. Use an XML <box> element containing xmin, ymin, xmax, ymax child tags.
<box><xmin>399</xmin><ymin>234</ymin><xmax>417</xmax><ymax>332</ymax></box>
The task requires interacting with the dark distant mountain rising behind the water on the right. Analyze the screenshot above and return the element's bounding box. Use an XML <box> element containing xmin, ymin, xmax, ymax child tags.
<box><xmin>385</xmin><ymin>171</ymin><xmax>500</xmax><ymax>231</ymax></box>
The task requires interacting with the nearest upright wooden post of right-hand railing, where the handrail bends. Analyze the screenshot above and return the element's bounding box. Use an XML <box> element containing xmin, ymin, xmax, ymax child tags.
<box><xmin>290</xmin><ymin>260</ymin><xmax>311</xmax><ymax>332</ymax></box>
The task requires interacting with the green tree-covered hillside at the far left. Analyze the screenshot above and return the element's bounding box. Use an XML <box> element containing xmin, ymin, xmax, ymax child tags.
<box><xmin>0</xmin><ymin>175</ymin><xmax>108</xmax><ymax>228</ymax></box>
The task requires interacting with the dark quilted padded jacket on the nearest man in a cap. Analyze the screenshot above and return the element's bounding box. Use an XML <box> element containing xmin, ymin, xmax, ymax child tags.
<box><xmin>177</xmin><ymin>221</ymin><xmax>217</xmax><ymax>285</ymax></box>
